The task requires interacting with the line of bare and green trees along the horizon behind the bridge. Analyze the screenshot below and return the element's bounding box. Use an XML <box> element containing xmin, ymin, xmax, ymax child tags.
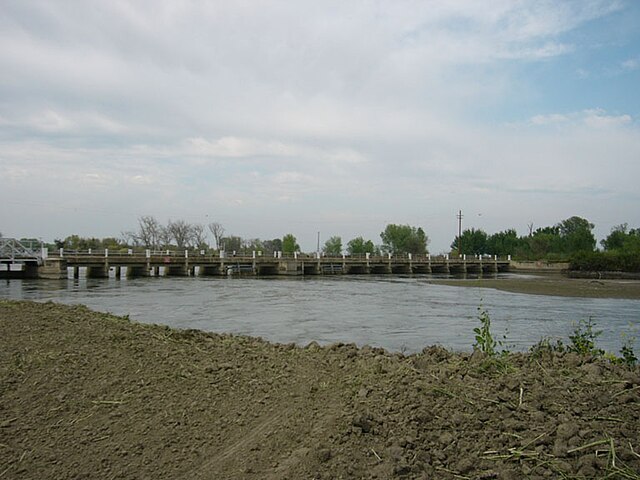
<box><xmin>42</xmin><ymin>216</ymin><xmax>640</xmax><ymax>270</ymax></box>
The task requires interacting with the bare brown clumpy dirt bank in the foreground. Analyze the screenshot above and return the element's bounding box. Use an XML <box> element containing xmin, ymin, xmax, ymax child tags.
<box><xmin>0</xmin><ymin>301</ymin><xmax>640</xmax><ymax>479</ymax></box>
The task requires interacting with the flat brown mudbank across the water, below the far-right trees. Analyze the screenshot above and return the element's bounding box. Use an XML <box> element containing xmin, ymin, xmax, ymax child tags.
<box><xmin>429</xmin><ymin>274</ymin><xmax>640</xmax><ymax>299</ymax></box>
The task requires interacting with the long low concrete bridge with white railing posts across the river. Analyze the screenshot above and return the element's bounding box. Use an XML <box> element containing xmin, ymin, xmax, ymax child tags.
<box><xmin>0</xmin><ymin>240</ymin><xmax>511</xmax><ymax>279</ymax></box>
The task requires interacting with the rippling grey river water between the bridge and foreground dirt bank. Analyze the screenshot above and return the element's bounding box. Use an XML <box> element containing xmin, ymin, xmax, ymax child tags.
<box><xmin>0</xmin><ymin>276</ymin><xmax>640</xmax><ymax>352</ymax></box>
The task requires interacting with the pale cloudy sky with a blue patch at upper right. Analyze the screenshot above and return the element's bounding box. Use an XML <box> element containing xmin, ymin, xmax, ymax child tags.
<box><xmin>0</xmin><ymin>0</ymin><xmax>640</xmax><ymax>253</ymax></box>
